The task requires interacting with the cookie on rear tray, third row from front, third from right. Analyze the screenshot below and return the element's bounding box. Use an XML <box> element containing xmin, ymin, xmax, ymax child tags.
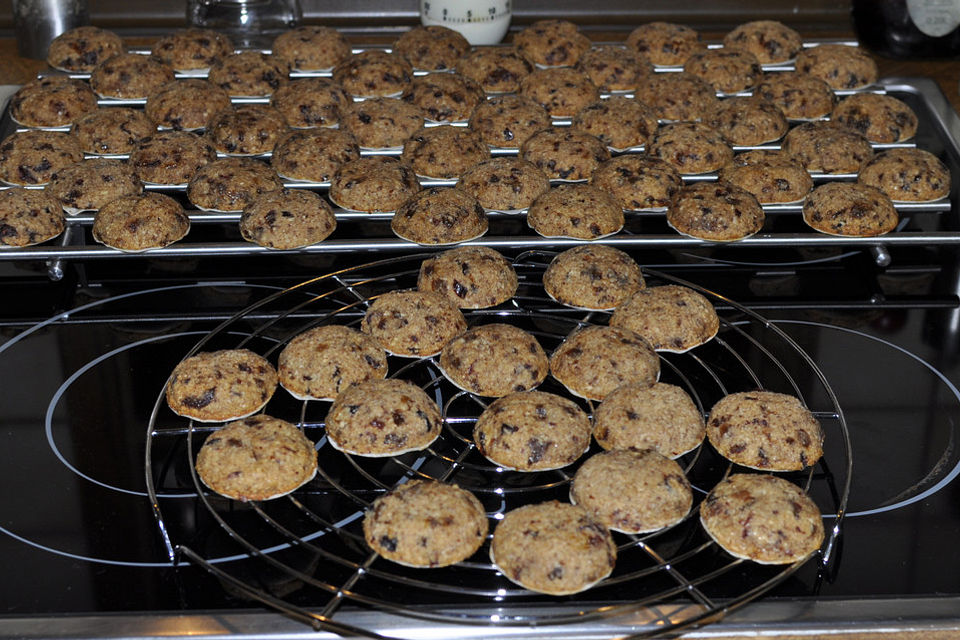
<box><xmin>520</xmin><ymin>128</ymin><xmax>610</xmax><ymax>180</ymax></box>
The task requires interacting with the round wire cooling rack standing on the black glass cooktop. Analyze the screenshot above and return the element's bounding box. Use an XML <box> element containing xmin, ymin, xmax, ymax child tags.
<box><xmin>145</xmin><ymin>251</ymin><xmax>852</xmax><ymax>638</ymax></box>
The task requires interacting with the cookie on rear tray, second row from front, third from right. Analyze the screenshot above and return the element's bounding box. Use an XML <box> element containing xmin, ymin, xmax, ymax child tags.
<box><xmin>590</xmin><ymin>153</ymin><xmax>683</xmax><ymax>211</ymax></box>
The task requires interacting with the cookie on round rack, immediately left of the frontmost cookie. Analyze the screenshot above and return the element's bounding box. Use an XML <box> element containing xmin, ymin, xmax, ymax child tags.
<box><xmin>363</xmin><ymin>480</ymin><xmax>488</xmax><ymax>567</ymax></box>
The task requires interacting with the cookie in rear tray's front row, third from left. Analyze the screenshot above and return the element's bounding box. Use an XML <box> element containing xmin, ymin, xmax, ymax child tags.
<box><xmin>240</xmin><ymin>189</ymin><xmax>337</xmax><ymax>249</ymax></box>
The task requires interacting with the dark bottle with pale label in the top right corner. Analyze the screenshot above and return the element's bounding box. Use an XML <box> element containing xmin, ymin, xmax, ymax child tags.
<box><xmin>852</xmin><ymin>0</ymin><xmax>960</xmax><ymax>58</ymax></box>
